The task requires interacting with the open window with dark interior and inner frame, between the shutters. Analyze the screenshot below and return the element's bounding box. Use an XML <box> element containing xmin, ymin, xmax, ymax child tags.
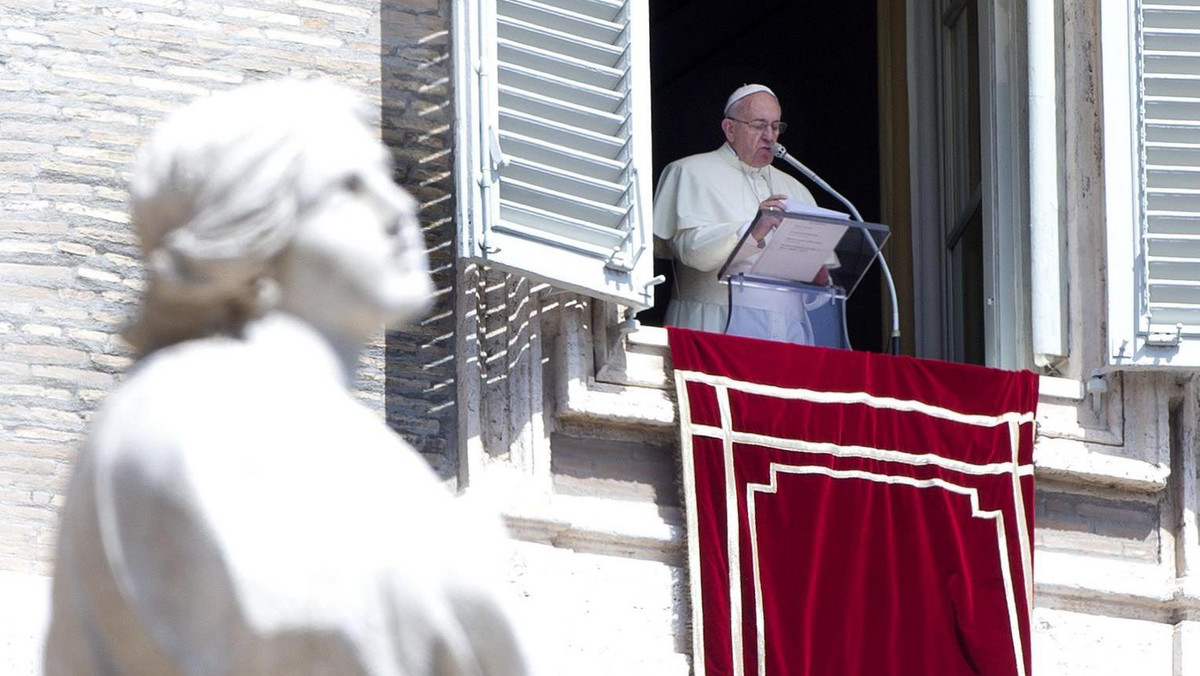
<box><xmin>652</xmin><ymin>0</ymin><xmax>1032</xmax><ymax>367</ymax></box>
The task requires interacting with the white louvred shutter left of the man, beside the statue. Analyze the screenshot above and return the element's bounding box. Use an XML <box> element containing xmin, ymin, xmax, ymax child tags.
<box><xmin>455</xmin><ymin>0</ymin><xmax>653</xmax><ymax>307</ymax></box>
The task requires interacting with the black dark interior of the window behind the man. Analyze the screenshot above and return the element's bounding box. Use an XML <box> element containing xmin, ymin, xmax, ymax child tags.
<box><xmin>638</xmin><ymin>0</ymin><xmax>884</xmax><ymax>352</ymax></box>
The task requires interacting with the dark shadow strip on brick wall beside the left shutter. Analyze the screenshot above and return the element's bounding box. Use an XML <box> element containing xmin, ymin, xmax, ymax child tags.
<box><xmin>379</xmin><ymin>0</ymin><xmax>457</xmax><ymax>479</ymax></box>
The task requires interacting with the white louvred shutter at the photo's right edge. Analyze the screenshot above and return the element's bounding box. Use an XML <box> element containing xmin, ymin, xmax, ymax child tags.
<box><xmin>1100</xmin><ymin>0</ymin><xmax>1200</xmax><ymax>366</ymax></box>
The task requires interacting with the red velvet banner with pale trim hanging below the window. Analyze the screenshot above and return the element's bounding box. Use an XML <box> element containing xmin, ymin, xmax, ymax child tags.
<box><xmin>670</xmin><ymin>329</ymin><xmax>1038</xmax><ymax>676</ymax></box>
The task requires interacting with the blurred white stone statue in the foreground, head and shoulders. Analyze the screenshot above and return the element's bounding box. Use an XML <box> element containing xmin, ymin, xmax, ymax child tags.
<box><xmin>46</xmin><ymin>82</ymin><xmax>528</xmax><ymax>676</ymax></box>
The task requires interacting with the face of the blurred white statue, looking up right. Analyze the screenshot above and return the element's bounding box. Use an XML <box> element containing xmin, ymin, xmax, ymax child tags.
<box><xmin>278</xmin><ymin>126</ymin><xmax>433</xmax><ymax>335</ymax></box>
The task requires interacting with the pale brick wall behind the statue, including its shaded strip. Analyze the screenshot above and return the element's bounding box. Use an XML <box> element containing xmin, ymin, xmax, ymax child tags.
<box><xmin>0</xmin><ymin>0</ymin><xmax>455</xmax><ymax>573</ymax></box>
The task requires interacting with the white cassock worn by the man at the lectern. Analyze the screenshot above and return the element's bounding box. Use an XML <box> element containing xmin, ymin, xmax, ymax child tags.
<box><xmin>654</xmin><ymin>143</ymin><xmax>816</xmax><ymax>343</ymax></box>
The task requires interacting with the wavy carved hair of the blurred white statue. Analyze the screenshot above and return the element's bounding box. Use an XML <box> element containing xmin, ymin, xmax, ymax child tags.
<box><xmin>124</xmin><ymin>80</ymin><xmax>370</xmax><ymax>355</ymax></box>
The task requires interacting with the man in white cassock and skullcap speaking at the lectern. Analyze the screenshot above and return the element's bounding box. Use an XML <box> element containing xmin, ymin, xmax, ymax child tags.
<box><xmin>654</xmin><ymin>84</ymin><xmax>815</xmax><ymax>343</ymax></box>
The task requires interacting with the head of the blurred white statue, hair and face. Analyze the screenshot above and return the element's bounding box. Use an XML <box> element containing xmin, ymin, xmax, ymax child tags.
<box><xmin>127</xmin><ymin>80</ymin><xmax>432</xmax><ymax>353</ymax></box>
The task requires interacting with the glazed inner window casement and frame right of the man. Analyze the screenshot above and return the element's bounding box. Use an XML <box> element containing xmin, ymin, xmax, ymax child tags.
<box><xmin>907</xmin><ymin>0</ymin><xmax>1032</xmax><ymax>369</ymax></box>
